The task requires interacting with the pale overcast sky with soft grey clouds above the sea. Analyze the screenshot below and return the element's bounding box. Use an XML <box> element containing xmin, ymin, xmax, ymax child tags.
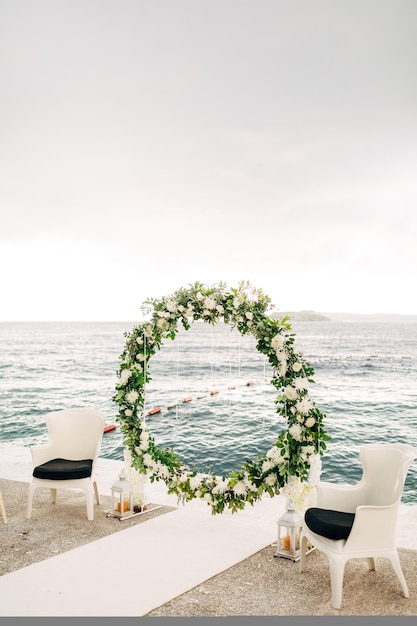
<box><xmin>0</xmin><ymin>0</ymin><xmax>417</xmax><ymax>321</ymax></box>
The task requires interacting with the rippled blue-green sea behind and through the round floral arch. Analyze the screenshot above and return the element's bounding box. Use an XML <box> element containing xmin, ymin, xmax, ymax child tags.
<box><xmin>0</xmin><ymin>321</ymin><xmax>417</xmax><ymax>504</ymax></box>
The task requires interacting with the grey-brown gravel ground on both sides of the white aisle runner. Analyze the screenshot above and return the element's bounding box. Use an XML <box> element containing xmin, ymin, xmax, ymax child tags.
<box><xmin>0</xmin><ymin>480</ymin><xmax>417</xmax><ymax>617</ymax></box>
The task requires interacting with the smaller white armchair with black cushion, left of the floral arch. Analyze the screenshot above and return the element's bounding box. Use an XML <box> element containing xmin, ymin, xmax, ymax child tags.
<box><xmin>26</xmin><ymin>408</ymin><xmax>105</xmax><ymax>520</ymax></box>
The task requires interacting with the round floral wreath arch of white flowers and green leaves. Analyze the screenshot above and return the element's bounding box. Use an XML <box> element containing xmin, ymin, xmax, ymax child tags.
<box><xmin>113</xmin><ymin>281</ymin><xmax>330</xmax><ymax>514</ymax></box>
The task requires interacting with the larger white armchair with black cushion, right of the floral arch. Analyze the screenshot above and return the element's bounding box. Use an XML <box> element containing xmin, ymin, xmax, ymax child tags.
<box><xmin>300</xmin><ymin>443</ymin><xmax>417</xmax><ymax>609</ymax></box>
